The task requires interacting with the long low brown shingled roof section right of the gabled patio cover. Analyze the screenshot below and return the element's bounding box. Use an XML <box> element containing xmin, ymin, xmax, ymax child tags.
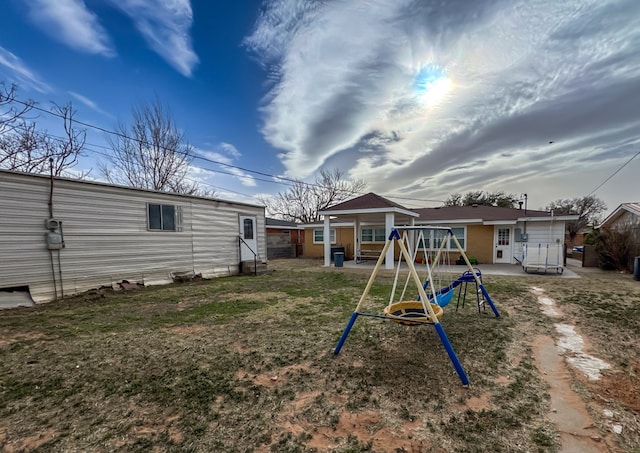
<box><xmin>414</xmin><ymin>205</ymin><xmax>551</xmax><ymax>222</ymax></box>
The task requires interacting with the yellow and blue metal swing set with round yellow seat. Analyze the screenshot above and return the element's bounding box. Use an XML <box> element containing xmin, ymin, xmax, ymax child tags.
<box><xmin>333</xmin><ymin>226</ymin><xmax>500</xmax><ymax>387</ymax></box>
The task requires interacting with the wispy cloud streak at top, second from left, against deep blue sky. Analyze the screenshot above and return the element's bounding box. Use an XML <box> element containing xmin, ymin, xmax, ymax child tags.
<box><xmin>110</xmin><ymin>0</ymin><xmax>199</xmax><ymax>77</ymax></box>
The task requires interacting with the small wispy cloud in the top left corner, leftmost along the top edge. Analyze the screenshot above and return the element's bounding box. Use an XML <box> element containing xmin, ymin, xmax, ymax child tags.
<box><xmin>25</xmin><ymin>0</ymin><xmax>115</xmax><ymax>57</ymax></box>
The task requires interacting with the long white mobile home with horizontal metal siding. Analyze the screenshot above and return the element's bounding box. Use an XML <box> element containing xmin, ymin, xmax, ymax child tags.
<box><xmin>0</xmin><ymin>170</ymin><xmax>267</xmax><ymax>302</ymax></box>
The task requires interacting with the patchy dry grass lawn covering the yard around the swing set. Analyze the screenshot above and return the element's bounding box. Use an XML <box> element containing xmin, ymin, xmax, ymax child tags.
<box><xmin>0</xmin><ymin>260</ymin><xmax>640</xmax><ymax>452</ymax></box>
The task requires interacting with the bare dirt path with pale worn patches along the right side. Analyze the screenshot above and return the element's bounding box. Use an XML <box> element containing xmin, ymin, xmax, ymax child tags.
<box><xmin>531</xmin><ymin>287</ymin><xmax>611</xmax><ymax>453</ymax></box>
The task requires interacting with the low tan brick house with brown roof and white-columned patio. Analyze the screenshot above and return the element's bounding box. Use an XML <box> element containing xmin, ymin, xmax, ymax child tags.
<box><xmin>303</xmin><ymin>193</ymin><xmax>578</xmax><ymax>267</ymax></box>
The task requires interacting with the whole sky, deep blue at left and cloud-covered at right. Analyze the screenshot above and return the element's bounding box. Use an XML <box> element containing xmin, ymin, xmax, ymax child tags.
<box><xmin>0</xmin><ymin>0</ymin><xmax>640</xmax><ymax>215</ymax></box>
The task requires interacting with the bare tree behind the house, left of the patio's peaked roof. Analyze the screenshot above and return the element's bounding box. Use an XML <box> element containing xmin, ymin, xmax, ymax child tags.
<box><xmin>260</xmin><ymin>169</ymin><xmax>366</xmax><ymax>223</ymax></box>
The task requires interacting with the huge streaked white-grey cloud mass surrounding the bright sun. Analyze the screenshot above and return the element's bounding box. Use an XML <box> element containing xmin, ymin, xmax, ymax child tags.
<box><xmin>244</xmin><ymin>0</ymin><xmax>640</xmax><ymax>207</ymax></box>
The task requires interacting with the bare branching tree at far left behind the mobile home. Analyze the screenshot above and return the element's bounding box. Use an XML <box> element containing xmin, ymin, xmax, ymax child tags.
<box><xmin>0</xmin><ymin>103</ymin><xmax>86</xmax><ymax>176</ymax></box>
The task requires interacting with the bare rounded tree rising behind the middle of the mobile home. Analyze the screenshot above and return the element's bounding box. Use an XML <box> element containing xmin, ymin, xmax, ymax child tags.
<box><xmin>99</xmin><ymin>100</ymin><xmax>198</xmax><ymax>194</ymax></box>
